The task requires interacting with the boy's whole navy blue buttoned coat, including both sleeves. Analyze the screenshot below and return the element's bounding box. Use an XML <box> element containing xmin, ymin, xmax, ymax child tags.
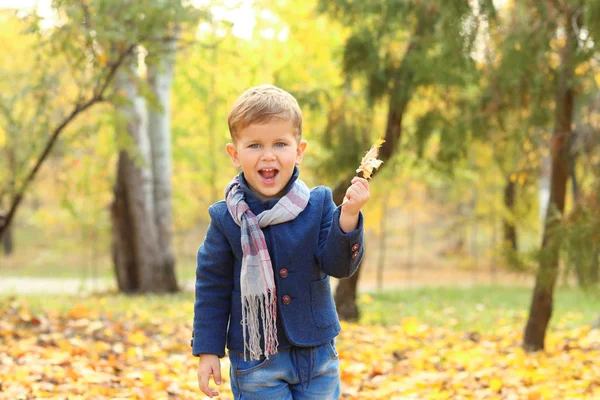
<box><xmin>192</xmin><ymin>168</ymin><xmax>363</xmax><ymax>357</ymax></box>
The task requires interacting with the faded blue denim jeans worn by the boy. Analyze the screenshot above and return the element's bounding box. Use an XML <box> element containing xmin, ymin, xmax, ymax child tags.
<box><xmin>229</xmin><ymin>340</ymin><xmax>340</xmax><ymax>400</ymax></box>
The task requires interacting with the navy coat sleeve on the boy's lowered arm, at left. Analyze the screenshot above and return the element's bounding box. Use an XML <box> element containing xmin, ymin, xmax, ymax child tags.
<box><xmin>192</xmin><ymin>206</ymin><xmax>234</xmax><ymax>357</ymax></box>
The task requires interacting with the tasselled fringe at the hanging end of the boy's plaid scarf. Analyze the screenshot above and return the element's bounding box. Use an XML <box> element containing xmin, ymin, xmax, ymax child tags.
<box><xmin>242</xmin><ymin>290</ymin><xmax>279</xmax><ymax>361</ymax></box>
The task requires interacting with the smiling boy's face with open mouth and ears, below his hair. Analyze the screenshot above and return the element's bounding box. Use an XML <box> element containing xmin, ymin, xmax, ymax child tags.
<box><xmin>226</xmin><ymin>120</ymin><xmax>307</xmax><ymax>200</ymax></box>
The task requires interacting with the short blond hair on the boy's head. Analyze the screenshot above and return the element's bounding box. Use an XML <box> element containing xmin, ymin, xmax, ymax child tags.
<box><xmin>227</xmin><ymin>85</ymin><xmax>302</xmax><ymax>140</ymax></box>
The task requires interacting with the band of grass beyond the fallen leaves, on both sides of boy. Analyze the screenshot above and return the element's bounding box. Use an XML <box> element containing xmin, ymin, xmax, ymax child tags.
<box><xmin>5</xmin><ymin>286</ymin><xmax>600</xmax><ymax>332</ymax></box>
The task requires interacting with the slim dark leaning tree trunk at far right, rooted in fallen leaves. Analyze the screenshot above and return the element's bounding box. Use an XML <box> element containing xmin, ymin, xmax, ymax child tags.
<box><xmin>523</xmin><ymin>12</ymin><xmax>577</xmax><ymax>351</ymax></box>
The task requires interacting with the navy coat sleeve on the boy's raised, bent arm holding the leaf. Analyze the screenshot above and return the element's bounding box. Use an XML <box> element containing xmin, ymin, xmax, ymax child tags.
<box><xmin>317</xmin><ymin>187</ymin><xmax>364</xmax><ymax>278</ymax></box>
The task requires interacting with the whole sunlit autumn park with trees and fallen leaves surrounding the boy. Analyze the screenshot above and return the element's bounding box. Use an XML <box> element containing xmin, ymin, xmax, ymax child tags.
<box><xmin>0</xmin><ymin>0</ymin><xmax>600</xmax><ymax>400</ymax></box>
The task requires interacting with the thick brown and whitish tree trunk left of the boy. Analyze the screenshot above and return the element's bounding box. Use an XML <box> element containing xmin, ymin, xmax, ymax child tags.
<box><xmin>112</xmin><ymin>62</ymin><xmax>176</xmax><ymax>293</ymax></box>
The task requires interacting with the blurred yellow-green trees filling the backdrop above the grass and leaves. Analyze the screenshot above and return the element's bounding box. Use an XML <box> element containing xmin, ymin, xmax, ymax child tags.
<box><xmin>0</xmin><ymin>0</ymin><xmax>600</xmax><ymax>291</ymax></box>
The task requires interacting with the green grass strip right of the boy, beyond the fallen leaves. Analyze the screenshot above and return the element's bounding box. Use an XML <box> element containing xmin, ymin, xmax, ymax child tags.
<box><xmin>359</xmin><ymin>286</ymin><xmax>600</xmax><ymax>332</ymax></box>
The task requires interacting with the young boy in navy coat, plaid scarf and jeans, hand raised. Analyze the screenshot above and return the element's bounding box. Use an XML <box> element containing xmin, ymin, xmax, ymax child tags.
<box><xmin>192</xmin><ymin>85</ymin><xmax>369</xmax><ymax>400</ymax></box>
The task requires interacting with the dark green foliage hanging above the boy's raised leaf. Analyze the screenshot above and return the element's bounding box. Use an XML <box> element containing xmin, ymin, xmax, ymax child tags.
<box><xmin>319</xmin><ymin>1</ymin><xmax>490</xmax><ymax>177</ymax></box>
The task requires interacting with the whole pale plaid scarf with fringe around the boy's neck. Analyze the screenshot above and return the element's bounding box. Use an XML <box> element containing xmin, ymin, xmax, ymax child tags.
<box><xmin>225</xmin><ymin>176</ymin><xmax>310</xmax><ymax>360</ymax></box>
